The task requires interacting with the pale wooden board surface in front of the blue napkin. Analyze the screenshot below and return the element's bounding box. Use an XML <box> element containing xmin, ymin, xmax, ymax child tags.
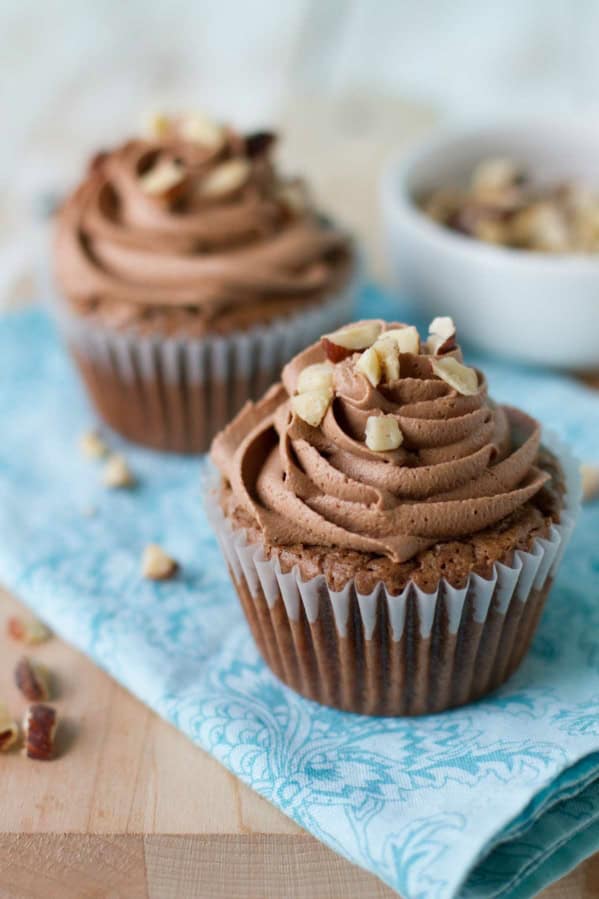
<box><xmin>0</xmin><ymin>590</ymin><xmax>599</xmax><ymax>899</ymax></box>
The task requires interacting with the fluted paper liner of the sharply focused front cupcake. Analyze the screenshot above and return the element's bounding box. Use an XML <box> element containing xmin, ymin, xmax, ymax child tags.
<box><xmin>207</xmin><ymin>434</ymin><xmax>580</xmax><ymax>715</ymax></box>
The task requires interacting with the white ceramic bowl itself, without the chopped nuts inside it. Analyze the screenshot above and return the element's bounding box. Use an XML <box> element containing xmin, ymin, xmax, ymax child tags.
<box><xmin>381</xmin><ymin>124</ymin><xmax>599</xmax><ymax>370</ymax></box>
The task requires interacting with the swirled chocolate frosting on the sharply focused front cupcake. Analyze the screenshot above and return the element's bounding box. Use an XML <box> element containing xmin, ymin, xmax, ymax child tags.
<box><xmin>212</xmin><ymin>322</ymin><xmax>548</xmax><ymax>562</ymax></box>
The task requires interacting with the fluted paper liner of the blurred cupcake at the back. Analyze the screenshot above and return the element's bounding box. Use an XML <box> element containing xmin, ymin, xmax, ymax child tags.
<box><xmin>53</xmin><ymin>272</ymin><xmax>359</xmax><ymax>453</ymax></box>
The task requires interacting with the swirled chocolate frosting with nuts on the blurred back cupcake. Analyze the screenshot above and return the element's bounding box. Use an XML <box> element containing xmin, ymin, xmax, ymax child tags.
<box><xmin>55</xmin><ymin>120</ymin><xmax>351</xmax><ymax>334</ymax></box>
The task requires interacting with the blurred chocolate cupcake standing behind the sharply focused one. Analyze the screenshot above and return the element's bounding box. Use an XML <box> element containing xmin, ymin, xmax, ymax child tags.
<box><xmin>54</xmin><ymin>115</ymin><xmax>355</xmax><ymax>452</ymax></box>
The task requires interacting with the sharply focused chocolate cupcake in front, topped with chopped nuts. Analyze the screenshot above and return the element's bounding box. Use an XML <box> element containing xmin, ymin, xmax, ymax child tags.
<box><xmin>208</xmin><ymin>318</ymin><xmax>576</xmax><ymax>715</ymax></box>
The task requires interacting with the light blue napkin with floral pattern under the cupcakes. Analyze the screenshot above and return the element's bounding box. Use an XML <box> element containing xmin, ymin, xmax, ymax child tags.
<box><xmin>0</xmin><ymin>291</ymin><xmax>599</xmax><ymax>899</ymax></box>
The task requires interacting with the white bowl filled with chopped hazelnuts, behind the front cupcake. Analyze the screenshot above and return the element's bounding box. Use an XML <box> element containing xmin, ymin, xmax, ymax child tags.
<box><xmin>381</xmin><ymin>123</ymin><xmax>599</xmax><ymax>371</ymax></box>
